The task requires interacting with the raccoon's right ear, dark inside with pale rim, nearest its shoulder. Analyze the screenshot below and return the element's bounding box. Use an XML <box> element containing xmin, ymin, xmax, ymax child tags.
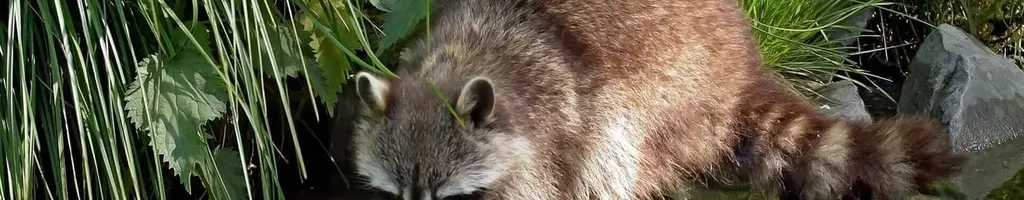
<box><xmin>456</xmin><ymin>77</ymin><xmax>495</xmax><ymax>125</ymax></box>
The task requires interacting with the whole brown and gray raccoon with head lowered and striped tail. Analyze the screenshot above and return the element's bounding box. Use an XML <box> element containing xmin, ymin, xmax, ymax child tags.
<box><xmin>351</xmin><ymin>0</ymin><xmax>963</xmax><ymax>200</ymax></box>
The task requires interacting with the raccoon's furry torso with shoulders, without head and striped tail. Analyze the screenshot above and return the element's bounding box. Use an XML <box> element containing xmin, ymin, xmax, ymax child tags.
<box><xmin>415</xmin><ymin>0</ymin><xmax>769</xmax><ymax>199</ymax></box>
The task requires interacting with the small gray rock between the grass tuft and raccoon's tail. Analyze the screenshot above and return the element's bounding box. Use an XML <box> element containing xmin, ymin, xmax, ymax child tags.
<box><xmin>817</xmin><ymin>80</ymin><xmax>871</xmax><ymax>122</ymax></box>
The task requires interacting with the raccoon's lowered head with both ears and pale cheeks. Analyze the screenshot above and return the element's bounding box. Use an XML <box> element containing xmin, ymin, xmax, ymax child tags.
<box><xmin>352</xmin><ymin>72</ymin><xmax>528</xmax><ymax>200</ymax></box>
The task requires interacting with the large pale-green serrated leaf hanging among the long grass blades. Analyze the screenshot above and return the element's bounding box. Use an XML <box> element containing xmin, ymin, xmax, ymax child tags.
<box><xmin>125</xmin><ymin>24</ymin><xmax>227</xmax><ymax>193</ymax></box>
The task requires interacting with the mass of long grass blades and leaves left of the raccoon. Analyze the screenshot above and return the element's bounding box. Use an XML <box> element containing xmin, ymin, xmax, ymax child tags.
<box><xmin>0</xmin><ymin>0</ymin><xmax>412</xmax><ymax>199</ymax></box>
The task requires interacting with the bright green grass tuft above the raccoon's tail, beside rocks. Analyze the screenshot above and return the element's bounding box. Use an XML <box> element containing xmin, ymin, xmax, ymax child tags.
<box><xmin>739</xmin><ymin>0</ymin><xmax>887</xmax><ymax>97</ymax></box>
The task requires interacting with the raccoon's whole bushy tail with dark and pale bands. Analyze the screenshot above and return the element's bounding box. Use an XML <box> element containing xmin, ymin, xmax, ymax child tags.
<box><xmin>740</xmin><ymin>114</ymin><xmax>964</xmax><ymax>200</ymax></box>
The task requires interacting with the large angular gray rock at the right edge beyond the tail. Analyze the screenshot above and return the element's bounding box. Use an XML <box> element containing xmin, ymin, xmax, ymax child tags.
<box><xmin>898</xmin><ymin>25</ymin><xmax>1024</xmax><ymax>199</ymax></box>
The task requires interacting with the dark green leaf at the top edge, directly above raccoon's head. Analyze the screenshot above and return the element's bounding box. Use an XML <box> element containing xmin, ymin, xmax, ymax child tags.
<box><xmin>376</xmin><ymin>0</ymin><xmax>429</xmax><ymax>52</ymax></box>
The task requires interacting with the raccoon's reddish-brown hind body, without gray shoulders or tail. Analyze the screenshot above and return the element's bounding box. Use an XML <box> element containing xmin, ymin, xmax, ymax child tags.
<box><xmin>542</xmin><ymin>0</ymin><xmax>770</xmax><ymax>199</ymax></box>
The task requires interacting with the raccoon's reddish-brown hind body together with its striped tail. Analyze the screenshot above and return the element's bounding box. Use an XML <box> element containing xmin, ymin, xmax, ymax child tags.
<box><xmin>545</xmin><ymin>0</ymin><xmax>962</xmax><ymax>199</ymax></box>
